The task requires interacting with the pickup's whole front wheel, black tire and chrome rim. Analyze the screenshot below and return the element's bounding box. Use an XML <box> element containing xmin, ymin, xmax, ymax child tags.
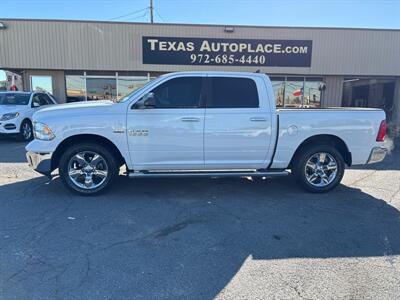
<box><xmin>59</xmin><ymin>143</ymin><xmax>119</xmax><ymax>195</ymax></box>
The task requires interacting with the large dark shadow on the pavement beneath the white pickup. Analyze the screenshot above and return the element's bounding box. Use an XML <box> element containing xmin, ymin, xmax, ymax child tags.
<box><xmin>0</xmin><ymin>177</ymin><xmax>400</xmax><ymax>299</ymax></box>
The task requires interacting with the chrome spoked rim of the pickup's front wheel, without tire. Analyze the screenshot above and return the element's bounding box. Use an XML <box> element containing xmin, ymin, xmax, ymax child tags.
<box><xmin>68</xmin><ymin>151</ymin><xmax>108</xmax><ymax>190</ymax></box>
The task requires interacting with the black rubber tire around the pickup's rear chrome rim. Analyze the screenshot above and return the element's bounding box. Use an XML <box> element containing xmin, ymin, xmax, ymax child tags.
<box><xmin>292</xmin><ymin>144</ymin><xmax>345</xmax><ymax>193</ymax></box>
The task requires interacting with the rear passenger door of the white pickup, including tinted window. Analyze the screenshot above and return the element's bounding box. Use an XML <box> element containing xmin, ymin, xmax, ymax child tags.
<box><xmin>204</xmin><ymin>75</ymin><xmax>272</xmax><ymax>169</ymax></box>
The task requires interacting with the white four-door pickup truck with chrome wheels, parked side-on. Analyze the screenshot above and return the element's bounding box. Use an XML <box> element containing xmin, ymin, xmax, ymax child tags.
<box><xmin>26</xmin><ymin>72</ymin><xmax>386</xmax><ymax>195</ymax></box>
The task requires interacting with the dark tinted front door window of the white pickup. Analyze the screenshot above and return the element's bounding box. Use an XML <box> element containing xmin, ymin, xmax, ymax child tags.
<box><xmin>152</xmin><ymin>77</ymin><xmax>202</xmax><ymax>108</ymax></box>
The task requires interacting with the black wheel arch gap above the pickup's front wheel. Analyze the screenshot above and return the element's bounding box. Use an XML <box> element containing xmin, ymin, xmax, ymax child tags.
<box><xmin>51</xmin><ymin>134</ymin><xmax>126</xmax><ymax>170</ymax></box>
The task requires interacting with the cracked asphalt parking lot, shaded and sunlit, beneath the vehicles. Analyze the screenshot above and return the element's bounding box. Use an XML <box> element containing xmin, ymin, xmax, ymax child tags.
<box><xmin>0</xmin><ymin>139</ymin><xmax>400</xmax><ymax>299</ymax></box>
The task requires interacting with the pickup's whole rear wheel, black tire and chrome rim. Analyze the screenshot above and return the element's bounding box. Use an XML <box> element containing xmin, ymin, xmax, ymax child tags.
<box><xmin>292</xmin><ymin>145</ymin><xmax>345</xmax><ymax>193</ymax></box>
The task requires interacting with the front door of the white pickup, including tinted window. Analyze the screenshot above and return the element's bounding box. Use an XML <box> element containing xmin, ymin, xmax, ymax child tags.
<box><xmin>127</xmin><ymin>76</ymin><xmax>205</xmax><ymax>170</ymax></box>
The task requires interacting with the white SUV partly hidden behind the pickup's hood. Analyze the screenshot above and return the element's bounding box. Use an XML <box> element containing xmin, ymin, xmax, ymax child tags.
<box><xmin>0</xmin><ymin>91</ymin><xmax>57</xmax><ymax>141</ymax></box>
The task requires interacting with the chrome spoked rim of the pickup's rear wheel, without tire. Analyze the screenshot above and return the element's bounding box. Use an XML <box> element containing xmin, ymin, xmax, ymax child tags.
<box><xmin>304</xmin><ymin>152</ymin><xmax>338</xmax><ymax>187</ymax></box>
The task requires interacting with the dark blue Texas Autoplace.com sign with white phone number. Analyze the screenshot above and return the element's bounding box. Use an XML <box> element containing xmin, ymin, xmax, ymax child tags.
<box><xmin>142</xmin><ymin>36</ymin><xmax>312</xmax><ymax>67</ymax></box>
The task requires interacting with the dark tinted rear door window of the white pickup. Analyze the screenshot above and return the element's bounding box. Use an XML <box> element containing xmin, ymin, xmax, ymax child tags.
<box><xmin>207</xmin><ymin>77</ymin><xmax>259</xmax><ymax>108</ymax></box>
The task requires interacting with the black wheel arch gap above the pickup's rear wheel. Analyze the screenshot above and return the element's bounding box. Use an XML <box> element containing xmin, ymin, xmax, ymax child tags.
<box><xmin>289</xmin><ymin>134</ymin><xmax>352</xmax><ymax>168</ymax></box>
